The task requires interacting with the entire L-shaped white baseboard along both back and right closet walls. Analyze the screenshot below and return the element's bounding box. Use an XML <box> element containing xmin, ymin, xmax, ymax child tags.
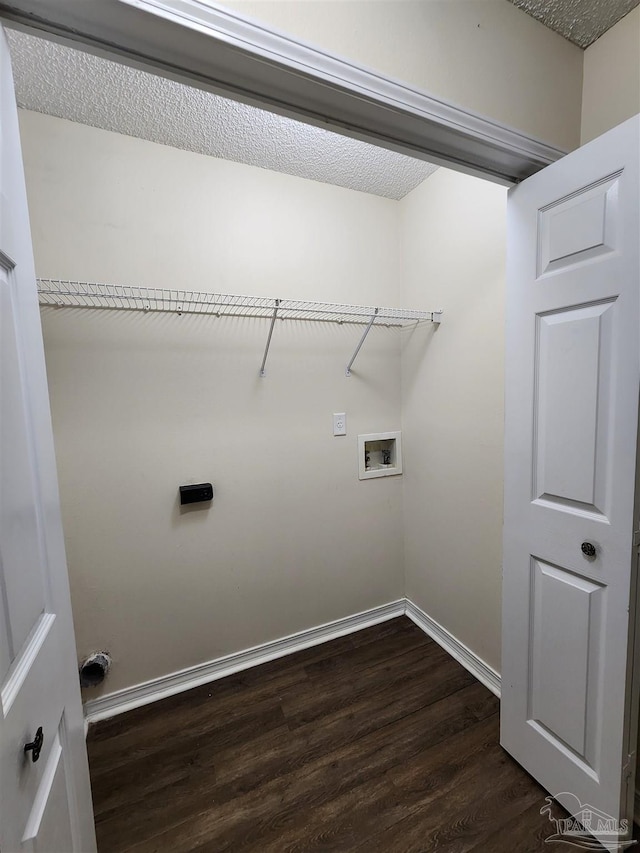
<box><xmin>84</xmin><ymin>598</ymin><xmax>500</xmax><ymax>724</ymax></box>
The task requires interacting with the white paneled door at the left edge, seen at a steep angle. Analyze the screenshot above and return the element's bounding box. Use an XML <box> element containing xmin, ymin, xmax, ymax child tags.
<box><xmin>0</xmin><ymin>30</ymin><xmax>95</xmax><ymax>853</ymax></box>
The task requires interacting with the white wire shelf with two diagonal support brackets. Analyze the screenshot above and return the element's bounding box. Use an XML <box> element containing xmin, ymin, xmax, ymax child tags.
<box><xmin>38</xmin><ymin>278</ymin><xmax>442</xmax><ymax>376</ymax></box>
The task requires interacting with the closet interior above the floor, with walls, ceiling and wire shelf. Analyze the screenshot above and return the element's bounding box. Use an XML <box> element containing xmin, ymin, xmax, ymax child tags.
<box><xmin>9</xmin><ymin>26</ymin><xmax>506</xmax><ymax>744</ymax></box>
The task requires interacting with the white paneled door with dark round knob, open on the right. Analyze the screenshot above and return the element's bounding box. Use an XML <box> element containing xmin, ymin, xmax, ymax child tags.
<box><xmin>502</xmin><ymin>117</ymin><xmax>640</xmax><ymax>842</ymax></box>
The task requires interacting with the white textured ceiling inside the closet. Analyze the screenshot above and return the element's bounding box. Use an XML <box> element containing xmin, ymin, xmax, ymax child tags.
<box><xmin>8</xmin><ymin>31</ymin><xmax>436</xmax><ymax>199</ymax></box>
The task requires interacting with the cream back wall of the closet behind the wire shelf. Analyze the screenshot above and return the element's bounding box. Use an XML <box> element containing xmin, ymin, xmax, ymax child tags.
<box><xmin>21</xmin><ymin>112</ymin><xmax>403</xmax><ymax>695</ymax></box>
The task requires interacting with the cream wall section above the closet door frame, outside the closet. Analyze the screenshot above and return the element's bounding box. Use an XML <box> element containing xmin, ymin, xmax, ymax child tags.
<box><xmin>224</xmin><ymin>0</ymin><xmax>582</xmax><ymax>150</ymax></box>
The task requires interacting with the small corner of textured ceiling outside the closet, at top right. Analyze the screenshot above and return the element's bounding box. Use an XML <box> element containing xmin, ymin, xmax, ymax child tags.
<box><xmin>511</xmin><ymin>0</ymin><xmax>640</xmax><ymax>47</ymax></box>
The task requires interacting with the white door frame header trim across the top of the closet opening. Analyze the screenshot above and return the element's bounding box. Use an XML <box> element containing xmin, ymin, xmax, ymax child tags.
<box><xmin>0</xmin><ymin>0</ymin><xmax>566</xmax><ymax>184</ymax></box>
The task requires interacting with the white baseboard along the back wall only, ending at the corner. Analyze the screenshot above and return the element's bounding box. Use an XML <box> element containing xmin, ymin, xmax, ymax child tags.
<box><xmin>84</xmin><ymin>598</ymin><xmax>405</xmax><ymax>723</ymax></box>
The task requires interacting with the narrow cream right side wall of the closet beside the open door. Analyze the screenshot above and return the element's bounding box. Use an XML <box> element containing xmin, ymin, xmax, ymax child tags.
<box><xmin>400</xmin><ymin>169</ymin><xmax>506</xmax><ymax>671</ymax></box>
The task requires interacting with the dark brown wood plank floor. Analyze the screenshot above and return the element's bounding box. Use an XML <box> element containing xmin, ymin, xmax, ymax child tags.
<box><xmin>88</xmin><ymin>617</ymin><xmax>596</xmax><ymax>853</ymax></box>
